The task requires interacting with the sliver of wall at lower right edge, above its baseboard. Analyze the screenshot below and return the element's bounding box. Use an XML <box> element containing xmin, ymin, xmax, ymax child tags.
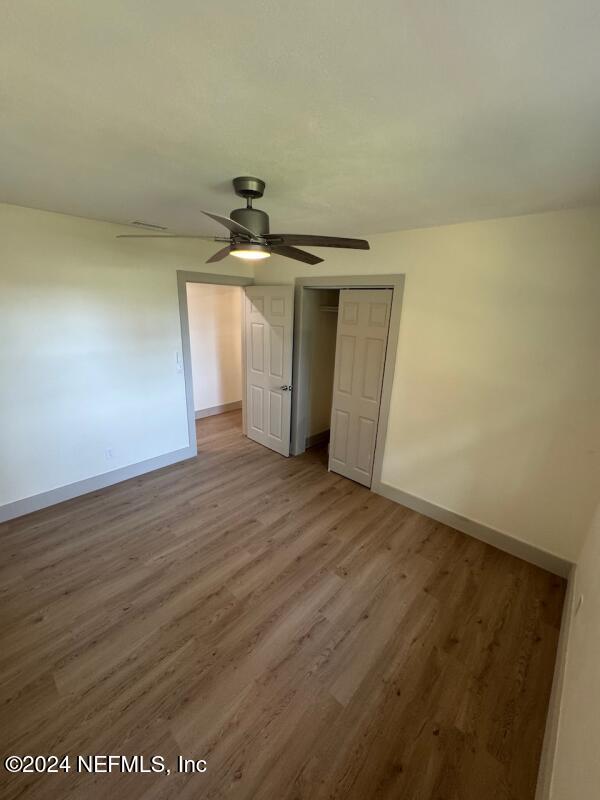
<box><xmin>538</xmin><ymin>504</ymin><xmax>600</xmax><ymax>800</ymax></box>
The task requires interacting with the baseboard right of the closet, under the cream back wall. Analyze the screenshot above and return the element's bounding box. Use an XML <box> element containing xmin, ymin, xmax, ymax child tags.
<box><xmin>371</xmin><ymin>483</ymin><xmax>573</xmax><ymax>578</ymax></box>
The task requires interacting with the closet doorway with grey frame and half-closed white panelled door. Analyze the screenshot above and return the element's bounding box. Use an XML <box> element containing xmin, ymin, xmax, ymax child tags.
<box><xmin>291</xmin><ymin>275</ymin><xmax>404</xmax><ymax>491</ymax></box>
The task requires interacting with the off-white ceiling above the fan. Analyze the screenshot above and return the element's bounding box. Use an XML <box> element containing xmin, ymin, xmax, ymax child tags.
<box><xmin>0</xmin><ymin>0</ymin><xmax>600</xmax><ymax>235</ymax></box>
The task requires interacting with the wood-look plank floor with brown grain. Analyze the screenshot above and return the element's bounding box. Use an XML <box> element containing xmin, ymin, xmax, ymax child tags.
<box><xmin>0</xmin><ymin>412</ymin><xmax>565</xmax><ymax>800</ymax></box>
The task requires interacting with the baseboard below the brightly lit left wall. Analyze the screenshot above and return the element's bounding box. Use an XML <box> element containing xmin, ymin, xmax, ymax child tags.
<box><xmin>0</xmin><ymin>446</ymin><xmax>197</xmax><ymax>522</ymax></box>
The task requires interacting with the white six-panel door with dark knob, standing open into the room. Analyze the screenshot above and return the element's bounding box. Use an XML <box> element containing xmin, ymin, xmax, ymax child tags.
<box><xmin>245</xmin><ymin>286</ymin><xmax>294</xmax><ymax>456</ymax></box>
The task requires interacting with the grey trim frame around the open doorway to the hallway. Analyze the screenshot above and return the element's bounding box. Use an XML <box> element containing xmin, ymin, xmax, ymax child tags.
<box><xmin>177</xmin><ymin>269</ymin><xmax>254</xmax><ymax>458</ymax></box>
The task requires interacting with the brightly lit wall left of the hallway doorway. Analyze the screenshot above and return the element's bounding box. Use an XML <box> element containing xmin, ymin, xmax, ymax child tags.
<box><xmin>0</xmin><ymin>205</ymin><xmax>249</xmax><ymax>506</ymax></box>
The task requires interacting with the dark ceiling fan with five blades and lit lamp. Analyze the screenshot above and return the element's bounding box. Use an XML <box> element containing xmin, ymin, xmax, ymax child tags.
<box><xmin>117</xmin><ymin>177</ymin><xmax>369</xmax><ymax>264</ymax></box>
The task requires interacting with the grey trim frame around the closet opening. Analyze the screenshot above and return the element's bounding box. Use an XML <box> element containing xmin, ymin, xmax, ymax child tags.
<box><xmin>290</xmin><ymin>274</ymin><xmax>405</xmax><ymax>492</ymax></box>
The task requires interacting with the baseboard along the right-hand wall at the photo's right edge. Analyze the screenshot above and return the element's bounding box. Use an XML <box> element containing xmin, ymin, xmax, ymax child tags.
<box><xmin>535</xmin><ymin>564</ymin><xmax>577</xmax><ymax>800</ymax></box>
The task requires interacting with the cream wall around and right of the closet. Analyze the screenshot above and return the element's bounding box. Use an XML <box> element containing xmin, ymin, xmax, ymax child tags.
<box><xmin>256</xmin><ymin>209</ymin><xmax>600</xmax><ymax>560</ymax></box>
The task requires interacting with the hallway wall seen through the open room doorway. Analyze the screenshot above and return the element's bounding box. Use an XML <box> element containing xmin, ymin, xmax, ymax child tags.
<box><xmin>187</xmin><ymin>283</ymin><xmax>242</xmax><ymax>411</ymax></box>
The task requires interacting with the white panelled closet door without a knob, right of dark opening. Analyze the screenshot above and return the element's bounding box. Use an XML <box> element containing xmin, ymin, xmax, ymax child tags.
<box><xmin>329</xmin><ymin>289</ymin><xmax>392</xmax><ymax>487</ymax></box>
